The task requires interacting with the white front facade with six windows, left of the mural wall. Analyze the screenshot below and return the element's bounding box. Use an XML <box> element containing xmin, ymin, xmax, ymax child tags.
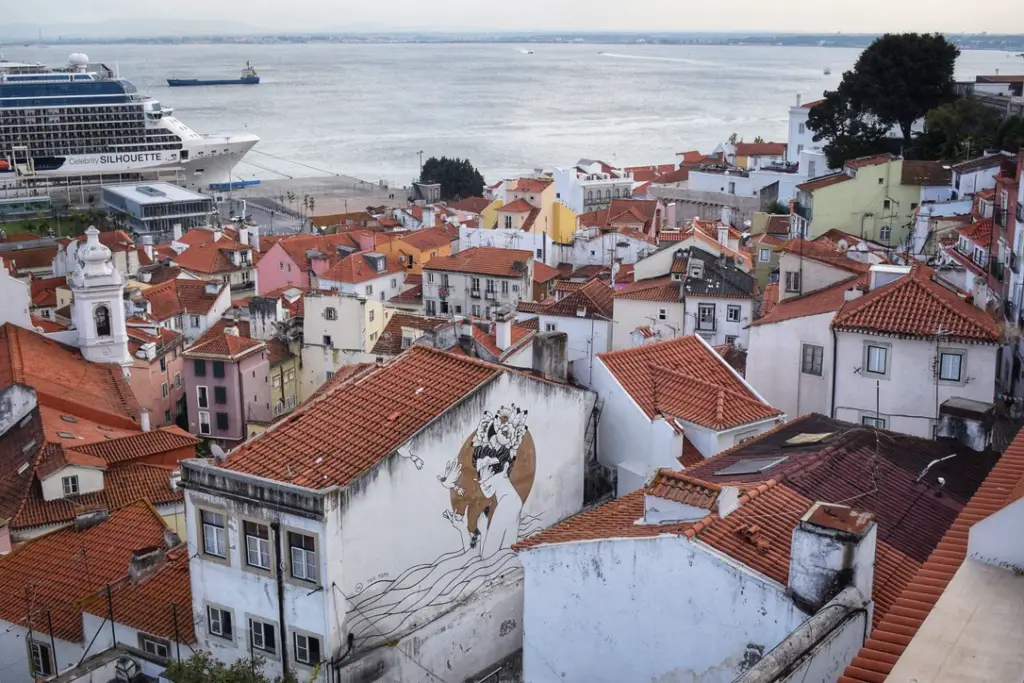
<box><xmin>183</xmin><ymin>489</ymin><xmax>332</xmax><ymax>680</ymax></box>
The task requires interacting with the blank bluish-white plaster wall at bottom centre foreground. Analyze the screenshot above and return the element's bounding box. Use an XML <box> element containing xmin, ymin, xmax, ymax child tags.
<box><xmin>520</xmin><ymin>536</ymin><xmax>806</xmax><ymax>683</ymax></box>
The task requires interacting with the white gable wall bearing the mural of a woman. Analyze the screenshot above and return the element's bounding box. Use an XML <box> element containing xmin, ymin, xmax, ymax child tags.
<box><xmin>322</xmin><ymin>373</ymin><xmax>588</xmax><ymax>681</ymax></box>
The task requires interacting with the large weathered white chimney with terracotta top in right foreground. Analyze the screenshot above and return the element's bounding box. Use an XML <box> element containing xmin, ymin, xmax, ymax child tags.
<box><xmin>786</xmin><ymin>503</ymin><xmax>877</xmax><ymax>614</ymax></box>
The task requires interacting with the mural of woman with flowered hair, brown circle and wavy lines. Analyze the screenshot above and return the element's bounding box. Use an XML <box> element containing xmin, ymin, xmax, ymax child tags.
<box><xmin>348</xmin><ymin>403</ymin><xmax>543</xmax><ymax>642</ymax></box>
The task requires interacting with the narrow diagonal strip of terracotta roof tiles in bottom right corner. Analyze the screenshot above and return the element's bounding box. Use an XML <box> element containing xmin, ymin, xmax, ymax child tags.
<box><xmin>838</xmin><ymin>434</ymin><xmax>1024</xmax><ymax>683</ymax></box>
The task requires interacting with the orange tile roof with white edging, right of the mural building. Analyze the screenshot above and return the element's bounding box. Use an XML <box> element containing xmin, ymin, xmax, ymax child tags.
<box><xmin>597</xmin><ymin>335</ymin><xmax>779</xmax><ymax>428</ymax></box>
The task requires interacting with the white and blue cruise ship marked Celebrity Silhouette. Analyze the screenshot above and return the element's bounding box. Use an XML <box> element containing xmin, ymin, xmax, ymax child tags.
<box><xmin>0</xmin><ymin>53</ymin><xmax>259</xmax><ymax>189</ymax></box>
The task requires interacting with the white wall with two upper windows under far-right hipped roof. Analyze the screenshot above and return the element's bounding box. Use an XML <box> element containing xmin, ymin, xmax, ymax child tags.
<box><xmin>831</xmin><ymin>332</ymin><xmax>998</xmax><ymax>438</ymax></box>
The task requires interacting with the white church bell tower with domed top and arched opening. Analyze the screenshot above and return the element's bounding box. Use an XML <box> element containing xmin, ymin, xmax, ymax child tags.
<box><xmin>71</xmin><ymin>227</ymin><xmax>131</xmax><ymax>375</ymax></box>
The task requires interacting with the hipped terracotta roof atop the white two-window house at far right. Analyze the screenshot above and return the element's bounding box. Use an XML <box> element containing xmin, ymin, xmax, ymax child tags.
<box><xmin>831</xmin><ymin>262</ymin><xmax>1002</xmax><ymax>343</ymax></box>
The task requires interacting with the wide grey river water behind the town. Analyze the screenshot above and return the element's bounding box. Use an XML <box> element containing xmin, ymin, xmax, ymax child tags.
<box><xmin>5</xmin><ymin>44</ymin><xmax>1024</xmax><ymax>184</ymax></box>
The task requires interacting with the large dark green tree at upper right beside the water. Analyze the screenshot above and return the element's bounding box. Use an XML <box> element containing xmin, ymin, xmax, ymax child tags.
<box><xmin>807</xmin><ymin>33</ymin><xmax>959</xmax><ymax>168</ymax></box>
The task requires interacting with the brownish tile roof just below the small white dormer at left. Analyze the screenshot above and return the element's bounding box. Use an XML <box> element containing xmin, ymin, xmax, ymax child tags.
<box><xmin>11</xmin><ymin>462</ymin><xmax>184</xmax><ymax>528</ymax></box>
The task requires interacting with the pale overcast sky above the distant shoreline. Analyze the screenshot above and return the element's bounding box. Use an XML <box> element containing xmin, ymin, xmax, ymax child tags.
<box><xmin>2</xmin><ymin>0</ymin><xmax>1024</xmax><ymax>34</ymax></box>
